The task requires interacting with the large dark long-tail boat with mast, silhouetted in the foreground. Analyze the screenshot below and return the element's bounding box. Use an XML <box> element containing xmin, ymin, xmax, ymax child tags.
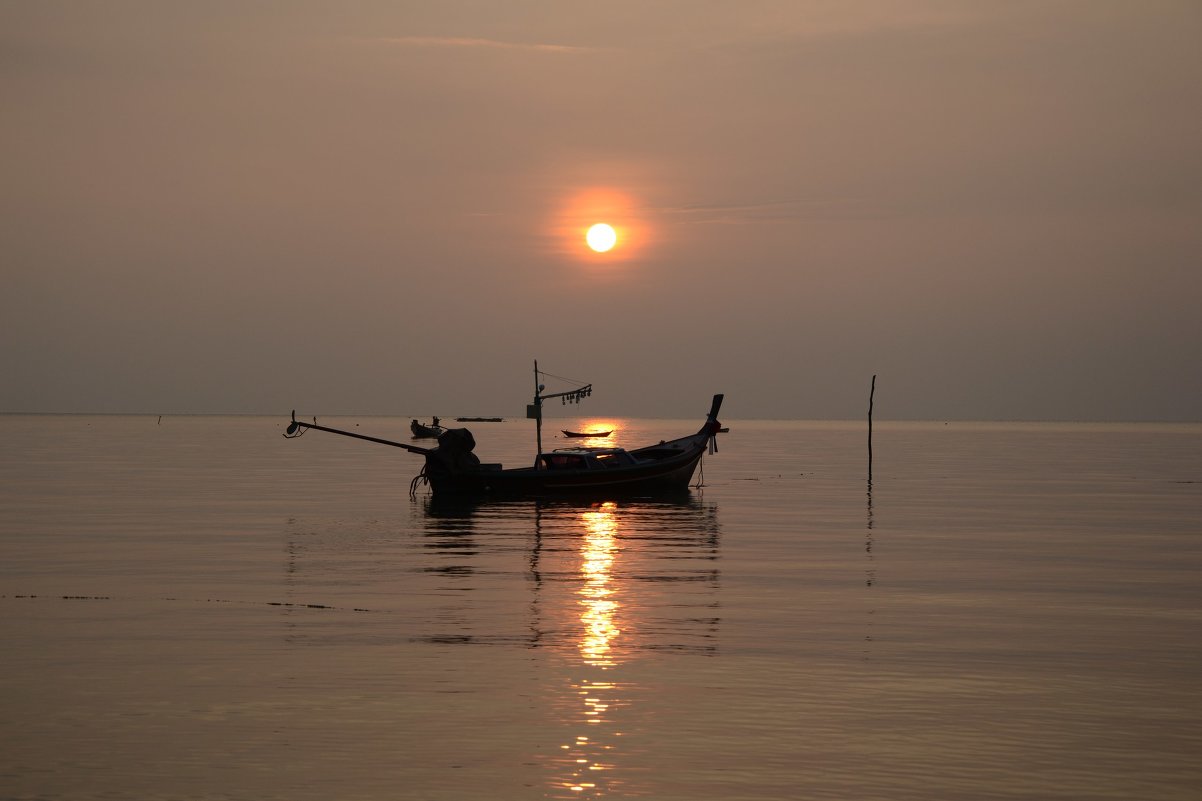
<box><xmin>285</xmin><ymin>362</ymin><xmax>722</xmax><ymax>498</ymax></box>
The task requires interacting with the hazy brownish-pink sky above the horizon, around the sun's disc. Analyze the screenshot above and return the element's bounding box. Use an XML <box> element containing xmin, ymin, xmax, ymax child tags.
<box><xmin>0</xmin><ymin>0</ymin><xmax>1202</xmax><ymax>420</ymax></box>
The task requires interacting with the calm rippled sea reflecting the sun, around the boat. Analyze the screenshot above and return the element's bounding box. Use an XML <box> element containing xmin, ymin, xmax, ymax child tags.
<box><xmin>0</xmin><ymin>415</ymin><xmax>1202</xmax><ymax>801</ymax></box>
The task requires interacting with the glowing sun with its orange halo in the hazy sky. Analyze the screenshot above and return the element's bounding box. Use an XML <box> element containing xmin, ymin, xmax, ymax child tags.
<box><xmin>554</xmin><ymin>188</ymin><xmax>649</xmax><ymax>266</ymax></box>
